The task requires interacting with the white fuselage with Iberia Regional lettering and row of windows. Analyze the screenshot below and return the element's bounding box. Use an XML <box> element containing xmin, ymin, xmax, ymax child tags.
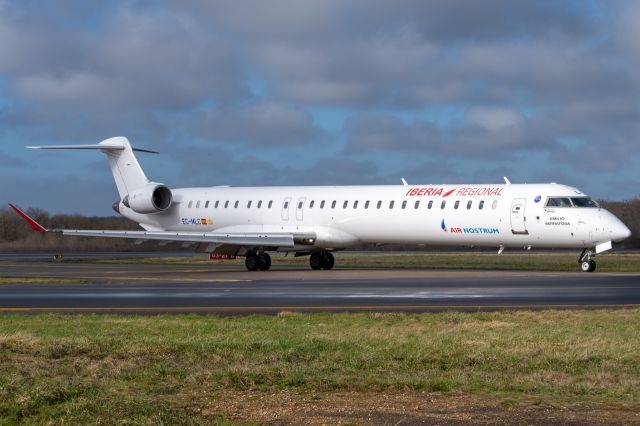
<box><xmin>120</xmin><ymin>184</ymin><xmax>629</xmax><ymax>248</ymax></box>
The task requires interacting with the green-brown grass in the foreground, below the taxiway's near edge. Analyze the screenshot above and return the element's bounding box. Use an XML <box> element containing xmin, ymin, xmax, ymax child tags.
<box><xmin>0</xmin><ymin>310</ymin><xmax>640</xmax><ymax>424</ymax></box>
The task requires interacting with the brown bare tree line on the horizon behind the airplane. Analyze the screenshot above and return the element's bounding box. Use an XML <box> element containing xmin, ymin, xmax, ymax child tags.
<box><xmin>0</xmin><ymin>198</ymin><xmax>640</xmax><ymax>252</ymax></box>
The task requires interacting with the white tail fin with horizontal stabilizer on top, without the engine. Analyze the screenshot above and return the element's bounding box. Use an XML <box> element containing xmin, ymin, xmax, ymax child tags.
<box><xmin>27</xmin><ymin>136</ymin><xmax>157</xmax><ymax>199</ymax></box>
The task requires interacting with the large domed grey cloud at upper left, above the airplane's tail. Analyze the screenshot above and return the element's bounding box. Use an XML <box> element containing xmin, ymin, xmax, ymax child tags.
<box><xmin>15</xmin><ymin>7</ymin><xmax>247</xmax><ymax>111</ymax></box>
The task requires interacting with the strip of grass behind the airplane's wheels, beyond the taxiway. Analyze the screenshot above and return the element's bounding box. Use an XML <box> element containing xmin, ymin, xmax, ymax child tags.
<box><xmin>72</xmin><ymin>252</ymin><xmax>640</xmax><ymax>272</ymax></box>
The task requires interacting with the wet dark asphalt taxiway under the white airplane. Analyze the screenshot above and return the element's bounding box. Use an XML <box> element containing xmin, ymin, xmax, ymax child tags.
<box><xmin>0</xmin><ymin>260</ymin><xmax>640</xmax><ymax>314</ymax></box>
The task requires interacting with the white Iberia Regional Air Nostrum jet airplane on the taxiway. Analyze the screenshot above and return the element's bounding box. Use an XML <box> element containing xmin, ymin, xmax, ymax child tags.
<box><xmin>10</xmin><ymin>137</ymin><xmax>631</xmax><ymax>272</ymax></box>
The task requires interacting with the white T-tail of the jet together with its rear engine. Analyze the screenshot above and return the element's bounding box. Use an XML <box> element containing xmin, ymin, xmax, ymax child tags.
<box><xmin>27</xmin><ymin>136</ymin><xmax>172</xmax><ymax>214</ymax></box>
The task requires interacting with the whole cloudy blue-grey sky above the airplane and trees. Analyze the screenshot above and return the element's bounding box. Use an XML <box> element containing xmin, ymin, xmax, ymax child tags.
<box><xmin>0</xmin><ymin>0</ymin><xmax>640</xmax><ymax>215</ymax></box>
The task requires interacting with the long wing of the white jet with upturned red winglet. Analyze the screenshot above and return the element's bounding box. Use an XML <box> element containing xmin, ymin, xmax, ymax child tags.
<box><xmin>9</xmin><ymin>204</ymin><xmax>294</xmax><ymax>247</ymax></box>
